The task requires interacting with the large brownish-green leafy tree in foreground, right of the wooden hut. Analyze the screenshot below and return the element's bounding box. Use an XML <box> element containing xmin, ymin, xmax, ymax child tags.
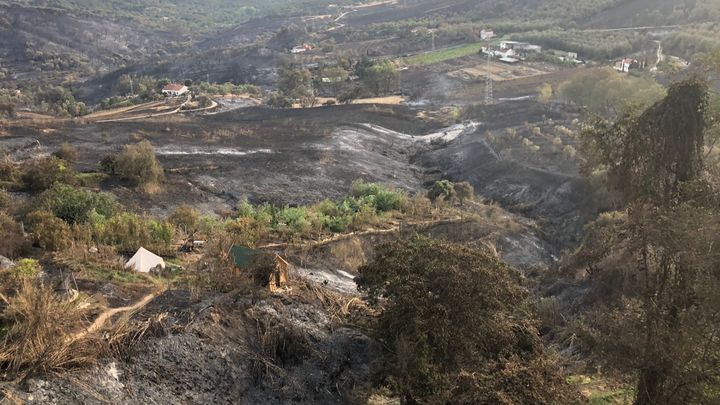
<box><xmin>358</xmin><ymin>236</ymin><xmax>575</xmax><ymax>404</ymax></box>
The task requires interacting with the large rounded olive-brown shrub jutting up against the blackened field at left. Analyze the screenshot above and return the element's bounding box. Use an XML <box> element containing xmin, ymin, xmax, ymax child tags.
<box><xmin>115</xmin><ymin>141</ymin><xmax>164</xmax><ymax>190</ymax></box>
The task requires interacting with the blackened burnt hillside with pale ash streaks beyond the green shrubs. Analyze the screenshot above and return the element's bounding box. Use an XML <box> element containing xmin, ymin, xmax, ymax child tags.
<box><xmin>0</xmin><ymin>101</ymin><xmax>586</xmax><ymax>240</ymax></box>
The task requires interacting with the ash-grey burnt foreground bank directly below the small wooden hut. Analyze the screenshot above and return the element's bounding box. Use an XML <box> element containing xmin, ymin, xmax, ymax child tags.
<box><xmin>15</xmin><ymin>287</ymin><xmax>379</xmax><ymax>404</ymax></box>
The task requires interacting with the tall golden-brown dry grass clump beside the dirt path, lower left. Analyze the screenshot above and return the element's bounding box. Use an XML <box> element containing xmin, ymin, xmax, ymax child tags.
<box><xmin>0</xmin><ymin>282</ymin><xmax>165</xmax><ymax>381</ymax></box>
